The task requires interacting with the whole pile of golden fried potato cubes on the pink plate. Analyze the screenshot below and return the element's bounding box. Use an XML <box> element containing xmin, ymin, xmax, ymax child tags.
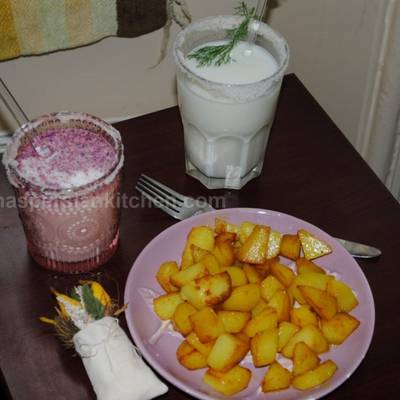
<box><xmin>153</xmin><ymin>219</ymin><xmax>359</xmax><ymax>395</ymax></box>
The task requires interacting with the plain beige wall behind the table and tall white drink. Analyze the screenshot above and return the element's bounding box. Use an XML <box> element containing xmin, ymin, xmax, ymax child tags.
<box><xmin>0</xmin><ymin>0</ymin><xmax>386</xmax><ymax>150</ymax></box>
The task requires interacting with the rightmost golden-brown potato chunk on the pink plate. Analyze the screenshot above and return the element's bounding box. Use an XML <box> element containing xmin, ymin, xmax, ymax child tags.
<box><xmin>321</xmin><ymin>313</ymin><xmax>360</xmax><ymax>344</ymax></box>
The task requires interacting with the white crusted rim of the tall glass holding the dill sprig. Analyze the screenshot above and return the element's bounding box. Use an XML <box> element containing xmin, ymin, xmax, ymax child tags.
<box><xmin>174</xmin><ymin>15</ymin><xmax>290</xmax><ymax>88</ymax></box>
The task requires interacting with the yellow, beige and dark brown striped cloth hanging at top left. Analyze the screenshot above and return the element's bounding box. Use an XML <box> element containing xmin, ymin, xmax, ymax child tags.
<box><xmin>0</xmin><ymin>0</ymin><xmax>167</xmax><ymax>60</ymax></box>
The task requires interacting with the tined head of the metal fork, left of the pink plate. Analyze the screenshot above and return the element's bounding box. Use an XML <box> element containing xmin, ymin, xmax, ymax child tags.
<box><xmin>136</xmin><ymin>174</ymin><xmax>215</xmax><ymax>220</ymax></box>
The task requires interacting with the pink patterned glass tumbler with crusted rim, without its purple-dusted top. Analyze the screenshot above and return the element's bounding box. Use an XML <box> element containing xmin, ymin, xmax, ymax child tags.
<box><xmin>3</xmin><ymin>112</ymin><xmax>124</xmax><ymax>273</ymax></box>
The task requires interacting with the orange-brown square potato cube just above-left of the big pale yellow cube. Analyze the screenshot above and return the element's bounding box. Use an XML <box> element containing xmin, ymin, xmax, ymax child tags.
<box><xmin>189</xmin><ymin>307</ymin><xmax>224</xmax><ymax>343</ymax></box>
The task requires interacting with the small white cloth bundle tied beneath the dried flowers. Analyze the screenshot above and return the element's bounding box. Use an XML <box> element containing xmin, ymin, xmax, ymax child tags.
<box><xmin>73</xmin><ymin>317</ymin><xmax>168</xmax><ymax>400</ymax></box>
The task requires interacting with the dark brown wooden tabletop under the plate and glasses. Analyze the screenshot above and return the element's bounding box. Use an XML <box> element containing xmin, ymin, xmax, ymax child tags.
<box><xmin>0</xmin><ymin>75</ymin><xmax>400</xmax><ymax>400</ymax></box>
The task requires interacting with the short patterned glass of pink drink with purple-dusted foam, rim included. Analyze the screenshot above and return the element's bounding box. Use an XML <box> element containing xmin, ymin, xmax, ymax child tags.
<box><xmin>3</xmin><ymin>112</ymin><xmax>123</xmax><ymax>273</ymax></box>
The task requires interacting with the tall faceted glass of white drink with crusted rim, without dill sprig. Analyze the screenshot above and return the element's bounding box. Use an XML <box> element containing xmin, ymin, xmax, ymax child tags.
<box><xmin>174</xmin><ymin>16</ymin><xmax>289</xmax><ymax>189</ymax></box>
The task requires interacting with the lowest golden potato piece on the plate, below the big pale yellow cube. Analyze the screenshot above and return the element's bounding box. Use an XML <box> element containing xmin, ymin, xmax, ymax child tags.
<box><xmin>203</xmin><ymin>365</ymin><xmax>251</xmax><ymax>396</ymax></box>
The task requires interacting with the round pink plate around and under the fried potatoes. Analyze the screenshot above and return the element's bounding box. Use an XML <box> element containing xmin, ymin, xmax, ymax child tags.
<box><xmin>125</xmin><ymin>208</ymin><xmax>375</xmax><ymax>400</ymax></box>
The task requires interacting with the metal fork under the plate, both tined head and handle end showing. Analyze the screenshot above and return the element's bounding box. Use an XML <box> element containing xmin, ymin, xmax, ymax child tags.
<box><xmin>136</xmin><ymin>174</ymin><xmax>381</xmax><ymax>258</ymax></box>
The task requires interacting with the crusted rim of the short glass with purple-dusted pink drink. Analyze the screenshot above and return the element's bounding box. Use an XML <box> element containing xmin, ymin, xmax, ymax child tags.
<box><xmin>3</xmin><ymin>111</ymin><xmax>124</xmax><ymax>200</ymax></box>
